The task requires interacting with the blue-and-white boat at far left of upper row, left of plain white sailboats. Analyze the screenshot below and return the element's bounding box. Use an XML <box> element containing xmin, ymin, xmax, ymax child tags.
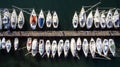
<box><xmin>2</xmin><ymin>8</ymin><xmax>10</xmax><ymax>29</ymax></box>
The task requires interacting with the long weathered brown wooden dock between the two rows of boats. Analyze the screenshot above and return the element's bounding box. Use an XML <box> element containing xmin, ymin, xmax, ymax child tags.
<box><xmin>0</xmin><ymin>31</ymin><xmax>120</xmax><ymax>37</ymax></box>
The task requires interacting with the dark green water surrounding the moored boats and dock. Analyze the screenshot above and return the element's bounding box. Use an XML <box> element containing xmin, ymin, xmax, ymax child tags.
<box><xmin>0</xmin><ymin>0</ymin><xmax>120</xmax><ymax>67</ymax></box>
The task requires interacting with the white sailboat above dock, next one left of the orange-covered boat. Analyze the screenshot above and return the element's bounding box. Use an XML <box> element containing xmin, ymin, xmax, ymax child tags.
<box><xmin>18</xmin><ymin>10</ymin><xmax>25</xmax><ymax>29</ymax></box>
